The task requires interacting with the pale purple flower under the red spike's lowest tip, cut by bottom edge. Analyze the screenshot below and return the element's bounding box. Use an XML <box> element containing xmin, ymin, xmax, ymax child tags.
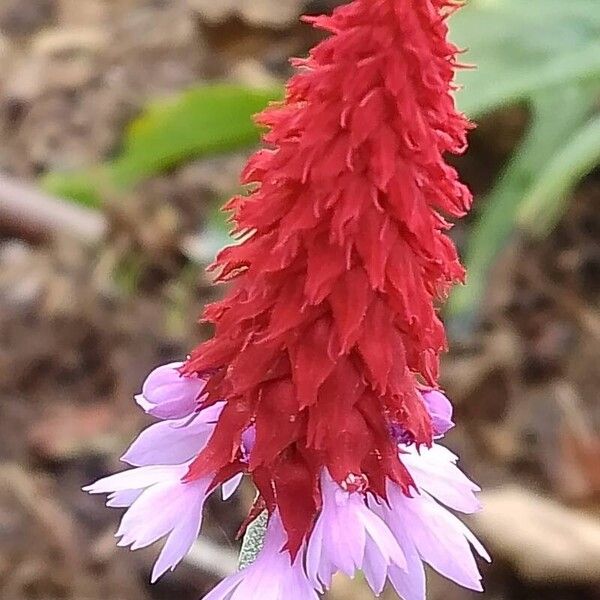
<box><xmin>203</xmin><ymin>513</ymin><xmax>319</xmax><ymax>600</ymax></box>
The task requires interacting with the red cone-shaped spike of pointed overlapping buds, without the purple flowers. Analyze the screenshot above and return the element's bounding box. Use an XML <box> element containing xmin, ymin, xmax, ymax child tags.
<box><xmin>183</xmin><ymin>0</ymin><xmax>471</xmax><ymax>553</ymax></box>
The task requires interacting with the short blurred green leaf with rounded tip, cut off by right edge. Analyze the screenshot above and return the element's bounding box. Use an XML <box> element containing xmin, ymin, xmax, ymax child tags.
<box><xmin>518</xmin><ymin>115</ymin><xmax>600</xmax><ymax>236</ymax></box>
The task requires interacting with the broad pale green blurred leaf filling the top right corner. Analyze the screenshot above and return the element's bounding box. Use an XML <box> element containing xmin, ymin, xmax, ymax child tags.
<box><xmin>450</xmin><ymin>0</ymin><xmax>600</xmax><ymax>117</ymax></box>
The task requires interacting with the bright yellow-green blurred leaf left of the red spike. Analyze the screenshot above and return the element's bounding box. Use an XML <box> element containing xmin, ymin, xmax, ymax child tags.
<box><xmin>41</xmin><ymin>84</ymin><xmax>283</xmax><ymax>207</ymax></box>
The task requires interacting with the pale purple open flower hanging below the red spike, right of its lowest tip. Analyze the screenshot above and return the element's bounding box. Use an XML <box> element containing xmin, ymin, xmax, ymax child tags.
<box><xmin>306</xmin><ymin>471</ymin><xmax>406</xmax><ymax>594</ymax></box>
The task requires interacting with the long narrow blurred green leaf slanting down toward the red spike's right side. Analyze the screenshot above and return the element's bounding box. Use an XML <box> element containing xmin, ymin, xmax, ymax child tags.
<box><xmin>448</xmin><ymin>88</ymin><xmax>596</xmax><ymax>320</ymax></box>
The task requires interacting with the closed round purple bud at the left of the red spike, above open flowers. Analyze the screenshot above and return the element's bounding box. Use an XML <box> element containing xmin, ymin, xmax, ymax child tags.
<box><xmin>135</xmin><ymin>362</ymin><xmax>206</xmax><ymax>419</ymax></box>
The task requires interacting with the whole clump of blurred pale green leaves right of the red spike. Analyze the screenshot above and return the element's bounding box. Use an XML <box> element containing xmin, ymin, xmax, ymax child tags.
<box><xmin>449</xmin><ymin>0</ymin><xmax>600</xmax><ymax>327</ymax></box>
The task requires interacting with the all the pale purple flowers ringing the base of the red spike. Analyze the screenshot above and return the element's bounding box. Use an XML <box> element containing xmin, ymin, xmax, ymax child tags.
<box><xmin>84</xmin><ymin>363</ymin><xmax>489</xmax><ymax>600</ymax></box>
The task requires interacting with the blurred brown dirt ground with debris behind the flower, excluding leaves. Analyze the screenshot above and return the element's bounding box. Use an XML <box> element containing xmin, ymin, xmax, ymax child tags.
<box><xmin>0</xmin><ymin>0</ymin><xmax>600</xmax><ymax>600</ymax></box>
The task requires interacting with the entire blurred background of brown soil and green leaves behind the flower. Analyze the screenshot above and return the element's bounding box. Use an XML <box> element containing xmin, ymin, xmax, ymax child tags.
<box><xmin>0</xmin><ymin>0</ymin><xmax>600</xmax><ymax>600</ymax></box>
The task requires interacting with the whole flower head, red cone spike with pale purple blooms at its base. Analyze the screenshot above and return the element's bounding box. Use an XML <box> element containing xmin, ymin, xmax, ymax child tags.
<box><xmin>87</xmin><ymin>0</ymin><xmax>488</xmax><ymax>600</ymax></box>
